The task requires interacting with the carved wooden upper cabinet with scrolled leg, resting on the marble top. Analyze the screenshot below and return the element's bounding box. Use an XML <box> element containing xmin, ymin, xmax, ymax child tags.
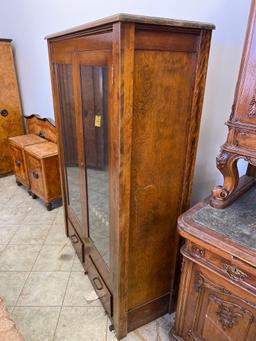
<box><xmin>211</xmin><ymin>0</ymin><xmax>256</xmax><ymax>208</ymax></box>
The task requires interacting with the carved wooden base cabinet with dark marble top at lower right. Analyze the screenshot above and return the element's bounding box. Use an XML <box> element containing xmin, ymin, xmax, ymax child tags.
<box><xmin>171</xmin><ymin>186</ymin><xmax>256</xmax><ymax>341</ymax></box>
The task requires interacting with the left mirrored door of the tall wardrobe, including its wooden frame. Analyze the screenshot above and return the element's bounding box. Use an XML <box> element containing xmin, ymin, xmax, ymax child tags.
<box><xmin>56</xmin><ymin>54</ymin><xmax>86</xmax><ymax>237</ymax></box>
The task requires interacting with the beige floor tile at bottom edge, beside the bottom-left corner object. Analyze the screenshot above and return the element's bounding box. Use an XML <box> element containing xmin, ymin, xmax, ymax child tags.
<box><xmin>12</xmin><ymin>307</ymin><xmax>60</xmax><ymax>341</ymax></box>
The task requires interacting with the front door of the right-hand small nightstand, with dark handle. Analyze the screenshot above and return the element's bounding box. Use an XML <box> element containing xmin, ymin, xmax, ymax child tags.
<box><xmin>26</xmin><ymin>153</ymin><xmax>44</xmax><ymax>196</ymax></box>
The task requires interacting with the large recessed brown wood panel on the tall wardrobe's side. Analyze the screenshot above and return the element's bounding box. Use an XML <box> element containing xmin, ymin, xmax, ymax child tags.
<box><xmin>128</xmin><ymin>50</ymin><xmax>196</xmax><ymax>309</ymax></box>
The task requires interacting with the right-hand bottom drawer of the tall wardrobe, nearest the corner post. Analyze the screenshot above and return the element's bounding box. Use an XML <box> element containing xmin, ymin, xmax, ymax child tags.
<box><xmin>85</xmin><ymin>256</ymin><xmax>112</xmax><ymax>316</ymax></box>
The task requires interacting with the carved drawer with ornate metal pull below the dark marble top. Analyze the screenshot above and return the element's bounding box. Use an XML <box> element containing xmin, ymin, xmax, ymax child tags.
<box><xmin>188</xmin><ymin>243</ymin><xmax>256</xmax><ymax>292</ymax></box>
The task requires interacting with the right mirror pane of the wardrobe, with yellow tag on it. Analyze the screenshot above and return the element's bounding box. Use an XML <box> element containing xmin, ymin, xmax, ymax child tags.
<box><xmin>80</xmin><ymin>65</ymin><xmax>109</xmax><ymax>266</ymax></box>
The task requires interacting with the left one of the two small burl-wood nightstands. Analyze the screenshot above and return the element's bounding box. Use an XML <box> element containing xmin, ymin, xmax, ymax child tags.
<box><xmin>9</xmin><ymin>134</ymin><xmax>46</xmax><ymax>189</ymax></box>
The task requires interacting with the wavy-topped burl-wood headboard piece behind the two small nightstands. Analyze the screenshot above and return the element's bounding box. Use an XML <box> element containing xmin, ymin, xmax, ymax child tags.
<box><xmin>24</xmin><ymin>115</ymin><xmax>57</xmax><ymax>143</ymax></box>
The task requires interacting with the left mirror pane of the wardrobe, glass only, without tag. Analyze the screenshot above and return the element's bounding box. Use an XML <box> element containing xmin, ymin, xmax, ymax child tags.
<box><xmin>56</xmin><ymin>64</ymin><xmax>82</xmax><ymax>223</ymax></box>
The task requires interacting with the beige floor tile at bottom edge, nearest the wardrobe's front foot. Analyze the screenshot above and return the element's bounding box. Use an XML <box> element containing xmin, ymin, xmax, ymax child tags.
<box><xmin>54</xmin><ymin>307</ymin><xmax>107</xmax><ymax>341</ymax></box>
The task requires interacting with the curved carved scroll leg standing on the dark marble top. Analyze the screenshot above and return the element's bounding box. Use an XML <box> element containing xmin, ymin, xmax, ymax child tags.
<box><xmin>211</xmin><ymin>151</ymin><xmax>239</xmax><ymax>208</ymax></box>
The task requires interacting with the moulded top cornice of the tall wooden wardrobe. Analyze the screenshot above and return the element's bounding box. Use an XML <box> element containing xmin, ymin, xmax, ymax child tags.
<box><xmin>45</xmin><ymin>13</ymin><xmax>215</xmax><ymax>39</ymax></box>
